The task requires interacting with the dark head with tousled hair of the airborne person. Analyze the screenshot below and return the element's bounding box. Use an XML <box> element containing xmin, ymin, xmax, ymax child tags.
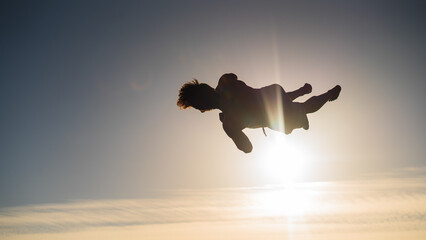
<box><xmin>177</xmin><ymin>79</ymin><xmax>219</xmax><ymax>112</ymax></box>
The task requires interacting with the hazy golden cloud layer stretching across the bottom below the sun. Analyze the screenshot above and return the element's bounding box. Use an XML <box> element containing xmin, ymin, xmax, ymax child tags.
<box><xmin>0</xmin><ymin>169</ymin><xmax>426</xmax><ymax>239</ymax></box>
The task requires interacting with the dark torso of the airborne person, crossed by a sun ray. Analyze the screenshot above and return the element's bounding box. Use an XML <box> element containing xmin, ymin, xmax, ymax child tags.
<box><xmin>217</xmin><ymin>80</ymin><xmax>309</xmax><ymax>133</ymax></box>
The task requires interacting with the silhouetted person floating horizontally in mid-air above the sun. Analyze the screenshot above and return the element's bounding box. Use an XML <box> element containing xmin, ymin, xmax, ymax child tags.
<box><xmin>177</xmin><ymin>73</ymin><xmax>342</xmax><ymax>153</ymax></box>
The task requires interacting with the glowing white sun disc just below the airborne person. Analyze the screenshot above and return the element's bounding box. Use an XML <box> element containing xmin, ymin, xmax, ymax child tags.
<box><xmin>260</xmin><ymin>134</ymin><xmax>310</xmax><ymax>187</ymax></box>
